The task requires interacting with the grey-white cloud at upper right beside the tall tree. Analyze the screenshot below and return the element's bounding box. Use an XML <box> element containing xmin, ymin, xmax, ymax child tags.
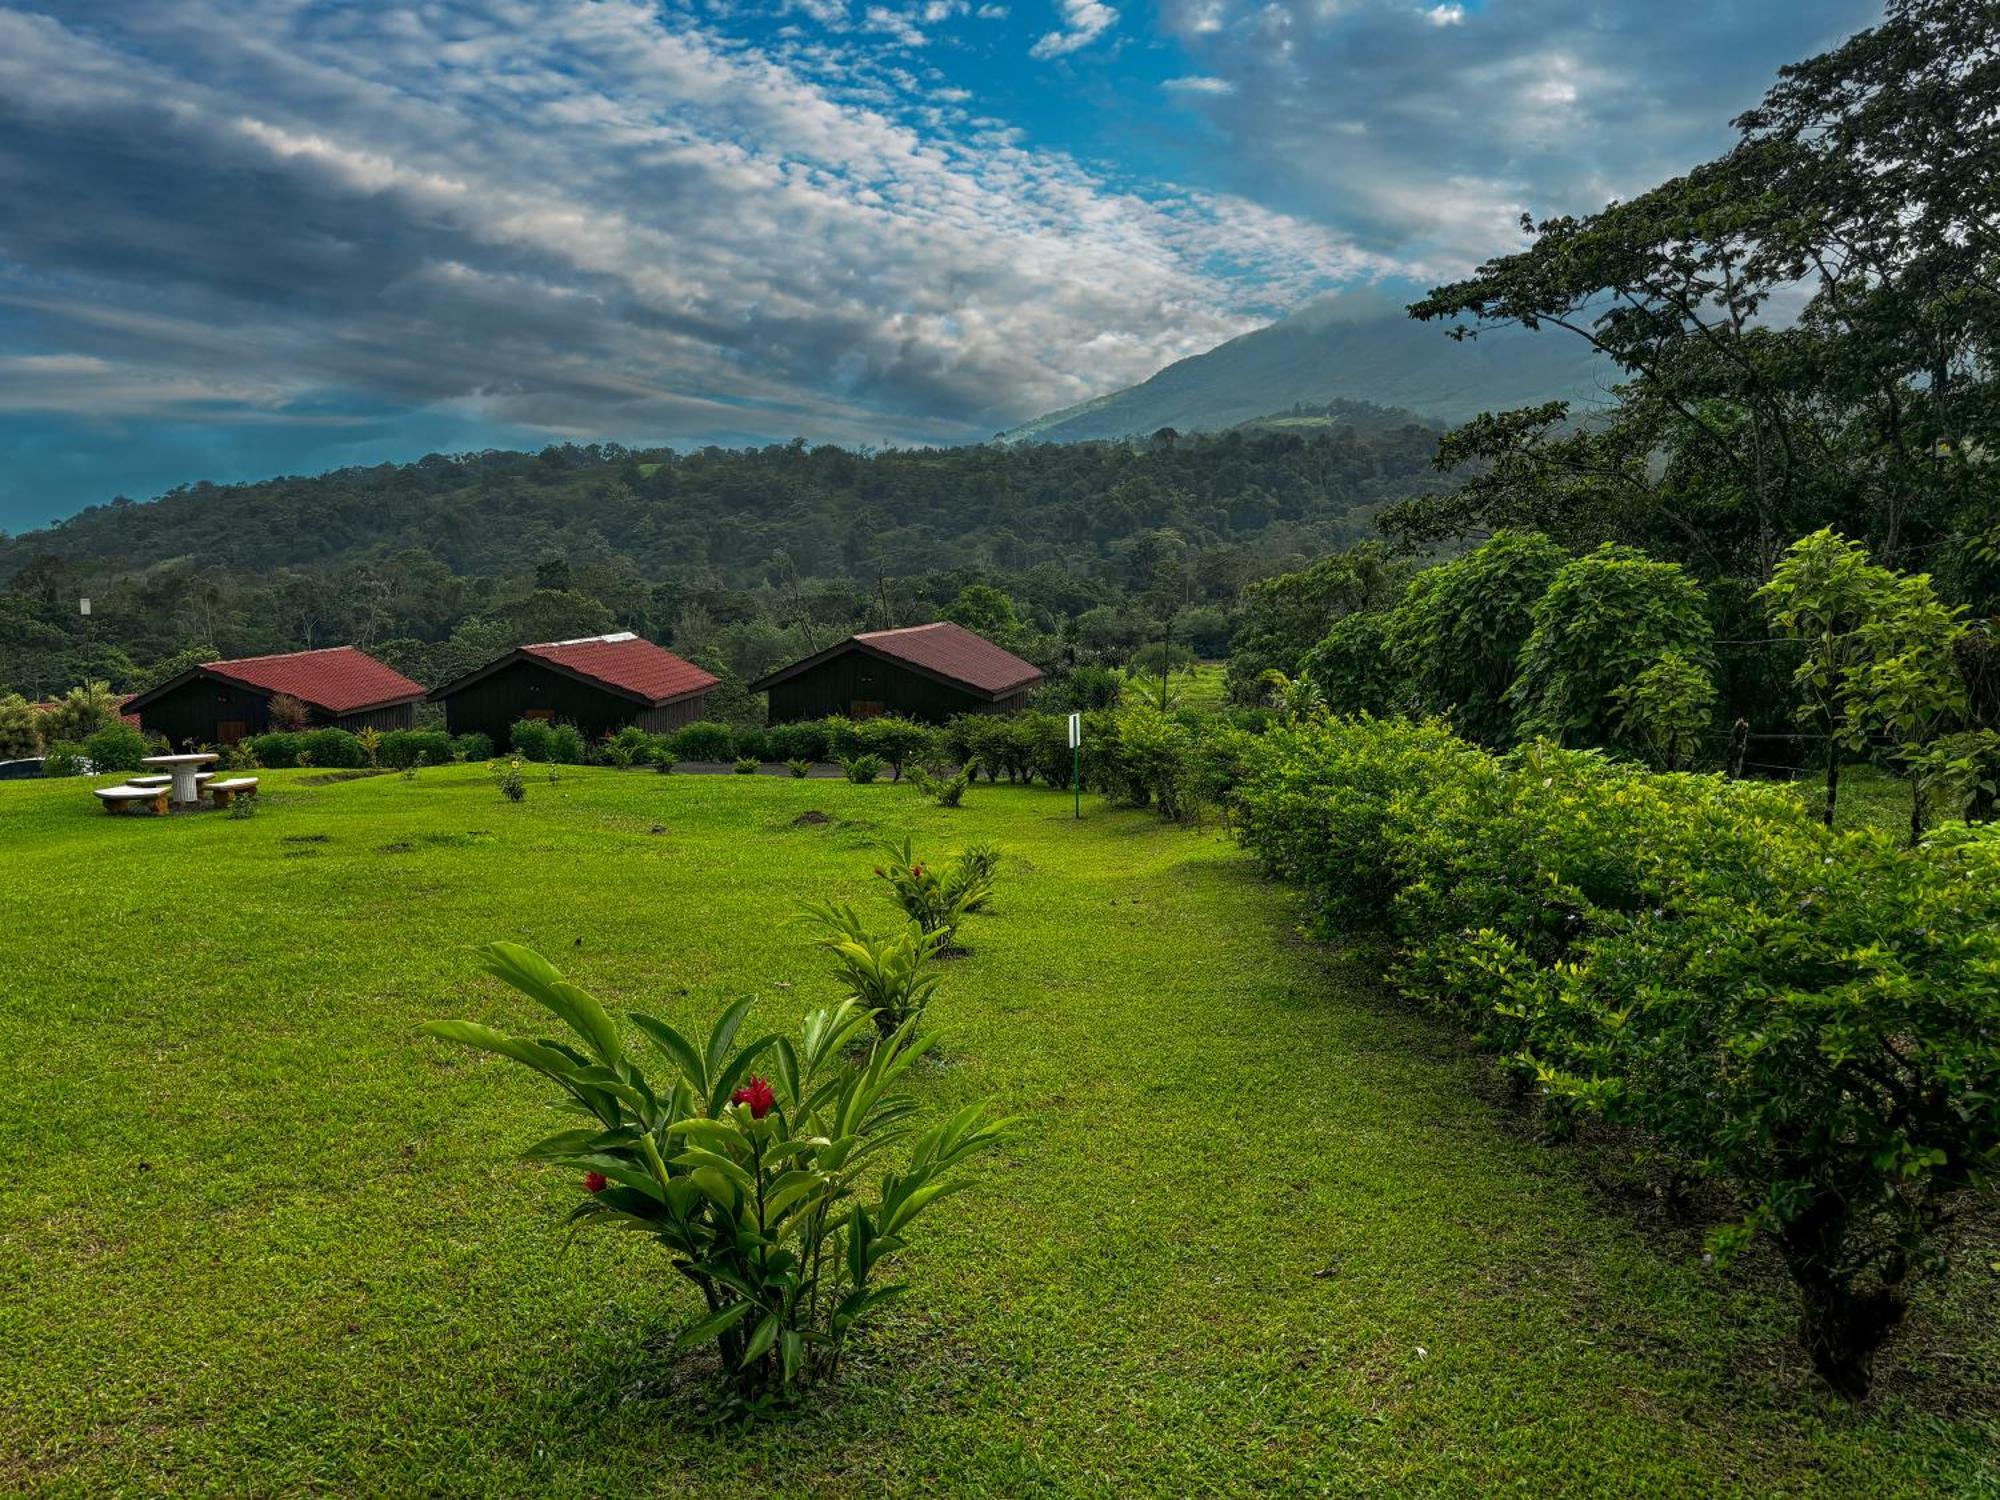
<box><xmin>1160</xmin><ymin>0</ymin><xmax>1880</xmax><ymax>276</ymax></box>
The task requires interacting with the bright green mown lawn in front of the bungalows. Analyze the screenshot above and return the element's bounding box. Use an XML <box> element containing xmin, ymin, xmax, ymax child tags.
<box><xmin>0</xmin><ymin>766</ymin><xmax>2000</xmax><ymax>1496</ymax></box>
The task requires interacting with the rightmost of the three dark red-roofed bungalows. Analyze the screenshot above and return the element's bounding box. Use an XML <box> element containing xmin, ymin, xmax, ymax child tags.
<box><xmin>750</xmin><ymin>620</ymin><xmax>1042</xmax><ymax>724</ymax></box>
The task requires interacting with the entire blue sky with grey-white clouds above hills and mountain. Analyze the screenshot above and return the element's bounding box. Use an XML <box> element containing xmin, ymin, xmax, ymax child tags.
<box><xmin>0</xmin><ymin>0</ymin><xmax>1880</xmax><ymax>532</ymax></box>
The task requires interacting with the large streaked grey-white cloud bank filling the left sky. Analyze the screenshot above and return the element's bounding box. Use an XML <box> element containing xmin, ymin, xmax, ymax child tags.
<box><xmin>0</xmin><ymin>0</ymin><xmax>1394</xmax><ymax>452</ymax></box>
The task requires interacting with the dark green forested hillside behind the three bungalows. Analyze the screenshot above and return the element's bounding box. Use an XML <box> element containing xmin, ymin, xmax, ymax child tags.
<box><xmin>0</xmin><ymin>420</ymin><xmax>1438</xmax><ymax>696</ymax></box>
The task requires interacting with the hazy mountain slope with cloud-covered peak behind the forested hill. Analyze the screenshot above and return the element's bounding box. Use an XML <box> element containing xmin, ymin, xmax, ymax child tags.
<box><xmin>1000</xmin><ymin>290</ymin><xmax>1610</xmax><ymax>442</ymax></box>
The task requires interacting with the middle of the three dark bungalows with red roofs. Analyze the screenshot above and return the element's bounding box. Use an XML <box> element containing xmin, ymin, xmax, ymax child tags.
<box><xmin>430</xmin><ymin>630</ymin><xmax>720</xmax><ymax>746</ymax></box>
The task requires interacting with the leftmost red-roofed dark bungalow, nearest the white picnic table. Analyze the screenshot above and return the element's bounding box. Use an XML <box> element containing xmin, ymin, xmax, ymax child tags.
<box><xmin>124</xmin><ymin>646</ymin><xmax>424</xmax><ymax>746</ymax></box>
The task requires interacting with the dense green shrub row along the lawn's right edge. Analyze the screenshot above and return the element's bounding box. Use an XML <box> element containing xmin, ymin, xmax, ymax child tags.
<box><xmin>1234</xmin><ymin>718</ymin><xmax>2000</xmax><ymax>1394</ymax></box>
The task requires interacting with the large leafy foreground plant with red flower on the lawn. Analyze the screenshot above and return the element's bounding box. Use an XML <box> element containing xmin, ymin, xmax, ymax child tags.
<box><xmin>424</xmin><ymin>944</ymin><xmax>1010</xmax><ymax>1412</ymax></box>
